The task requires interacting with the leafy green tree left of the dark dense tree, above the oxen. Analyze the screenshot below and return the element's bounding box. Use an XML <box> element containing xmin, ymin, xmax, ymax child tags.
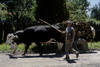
<box><xmin>0</xmin><ymin>0</ymin><xmax>36</xmax><ymax>31</ymax></box>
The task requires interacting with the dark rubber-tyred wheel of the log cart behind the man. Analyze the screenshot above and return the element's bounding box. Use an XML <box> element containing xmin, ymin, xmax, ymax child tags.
<box><xmin>73</xmin><ymin>39</ymin><xmax>88</xmax><ymax>53</ymax></box>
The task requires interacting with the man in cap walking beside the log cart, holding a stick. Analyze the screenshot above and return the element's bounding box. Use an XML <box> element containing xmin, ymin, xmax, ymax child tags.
<box><xmin>59</xmin><ymin>21</ymin><xmax>79</xmax><ymax>59</ymax></box>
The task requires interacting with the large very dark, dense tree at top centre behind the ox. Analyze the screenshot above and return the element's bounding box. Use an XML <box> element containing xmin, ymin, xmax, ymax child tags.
<box><xmin>35</xmin><ymin>0</ymin><xmax>69</xmax><ymax>24</ymax></box>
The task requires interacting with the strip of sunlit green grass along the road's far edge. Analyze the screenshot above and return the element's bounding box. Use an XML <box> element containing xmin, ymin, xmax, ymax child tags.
<box><xmin>0</xmin><ymin>41</ymin><xmax>100</xmax><ymax>51</ymax></box>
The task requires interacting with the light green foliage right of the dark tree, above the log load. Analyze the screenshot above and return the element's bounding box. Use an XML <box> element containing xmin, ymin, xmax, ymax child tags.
<box><xmin>66</xmin><ymin>0</ymin><xmax>90</xmax><ymax>21</ymax></box>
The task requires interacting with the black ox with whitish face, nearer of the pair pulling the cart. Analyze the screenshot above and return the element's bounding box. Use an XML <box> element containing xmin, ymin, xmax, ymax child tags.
<box><xmin>6</xmin><ymin>24</ymin><xmax>64</xmax><ymax>55</ymax></box>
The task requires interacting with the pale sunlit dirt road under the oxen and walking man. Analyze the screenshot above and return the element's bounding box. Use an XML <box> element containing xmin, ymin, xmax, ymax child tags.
<box><xmin>0</xmin><ymin>51</ymin><xmax>100</xmax><ymax>67</ymax></box>
